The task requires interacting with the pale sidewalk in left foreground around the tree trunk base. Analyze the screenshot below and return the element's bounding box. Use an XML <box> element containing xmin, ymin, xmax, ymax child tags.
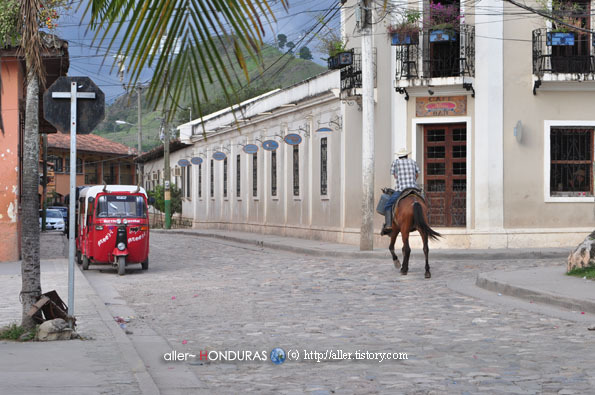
<box><xmin>0</xmin><ymin>258</ymin><xmax>158</xmax><ymax>394</ymax></box>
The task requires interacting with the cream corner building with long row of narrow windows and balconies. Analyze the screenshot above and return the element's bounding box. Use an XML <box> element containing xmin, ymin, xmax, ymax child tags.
<box><xmin>139</xmin><ymin>0</ymin><xmax>595</xmax><ymax>248</ymax></box>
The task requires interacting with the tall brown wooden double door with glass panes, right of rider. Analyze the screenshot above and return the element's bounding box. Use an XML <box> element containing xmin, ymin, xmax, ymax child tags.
<box><xmin>424</xmin><ymin>123</ymin><xmax>467</xmax><ymax>226</ymax></box>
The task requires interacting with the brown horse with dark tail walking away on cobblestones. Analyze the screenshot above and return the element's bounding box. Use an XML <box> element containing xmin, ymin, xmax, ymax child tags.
<box><xmin>388</xmin><ymin>193</ymin><xmax>441</xmax><ymax>278</ymax></box>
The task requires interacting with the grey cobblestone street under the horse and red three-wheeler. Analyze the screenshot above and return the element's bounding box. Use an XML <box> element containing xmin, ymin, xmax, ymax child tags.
<box><xmin>81</xmin><ymin>234</ymin><xmax>595</xmax><ymax>394</ymax></box>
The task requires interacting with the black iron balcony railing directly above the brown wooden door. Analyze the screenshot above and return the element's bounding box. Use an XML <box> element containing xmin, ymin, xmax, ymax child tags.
<box><xmin>396</xmin><ymin>24</ymin><xmax>475</xmax><ymax>80</ymax></box>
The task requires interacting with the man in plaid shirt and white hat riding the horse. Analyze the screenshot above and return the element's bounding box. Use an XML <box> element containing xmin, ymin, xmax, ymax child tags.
<box><xmin>380</xmin><ymin>148</ymin><xmax>419</xmax><ymax>236</ymax></box>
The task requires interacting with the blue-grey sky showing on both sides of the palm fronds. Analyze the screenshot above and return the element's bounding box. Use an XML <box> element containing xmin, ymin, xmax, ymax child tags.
<box><xmin>57</xmin><ymin>0</ymin><xmax>340</xmax><ymax>103</ymax></box>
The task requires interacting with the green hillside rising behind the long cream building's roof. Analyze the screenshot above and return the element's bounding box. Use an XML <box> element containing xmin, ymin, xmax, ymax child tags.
<box><xmin>93</xmin><ymin>45</ymin><xmax>326</xmax><ymax>151</ymax></box>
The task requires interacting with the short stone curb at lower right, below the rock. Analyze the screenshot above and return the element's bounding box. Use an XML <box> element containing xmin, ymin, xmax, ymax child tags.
<box><xmin>475</xmin><ymin>273</ymin><xmax>595</xmax><ymax>314</ymax></box>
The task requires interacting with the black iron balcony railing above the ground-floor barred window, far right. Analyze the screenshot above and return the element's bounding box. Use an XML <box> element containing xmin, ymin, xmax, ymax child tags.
<box><xmin>533</xmin><ymin>29</ymin><xmax>595</xmax><ymax>79</ymax></box>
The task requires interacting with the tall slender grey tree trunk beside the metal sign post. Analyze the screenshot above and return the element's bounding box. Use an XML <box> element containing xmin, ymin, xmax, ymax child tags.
<box><xmin>0</xmin><ymin>0</ymin><xmax>66</xmax><ymax>330</ymax></box>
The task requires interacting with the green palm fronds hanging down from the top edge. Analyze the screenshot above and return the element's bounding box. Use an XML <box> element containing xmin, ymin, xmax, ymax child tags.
<box><xmin>85</xmin><ymin>0</ymin><xmax>288</xmax><ymax>121</ymax></box>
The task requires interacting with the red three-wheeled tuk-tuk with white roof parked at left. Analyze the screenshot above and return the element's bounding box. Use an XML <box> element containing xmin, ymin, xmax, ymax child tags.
<box><xmin>76</xmin><ymin>185</ymin><xmax>149</xmax><ymax>275</ymax></box>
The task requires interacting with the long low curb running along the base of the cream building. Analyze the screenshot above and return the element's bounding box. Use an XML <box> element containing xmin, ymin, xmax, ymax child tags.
<box><xmin>151</xmin><ymin>229</ymin><xmax>570</xmax><ymax>261</ymax></box>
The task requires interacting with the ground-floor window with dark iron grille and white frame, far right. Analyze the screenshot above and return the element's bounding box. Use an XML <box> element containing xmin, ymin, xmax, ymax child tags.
<box><xmin>550</xmin><ymin>126</ymin><xmax>594</xmax><ymax>197</ymax></box>
